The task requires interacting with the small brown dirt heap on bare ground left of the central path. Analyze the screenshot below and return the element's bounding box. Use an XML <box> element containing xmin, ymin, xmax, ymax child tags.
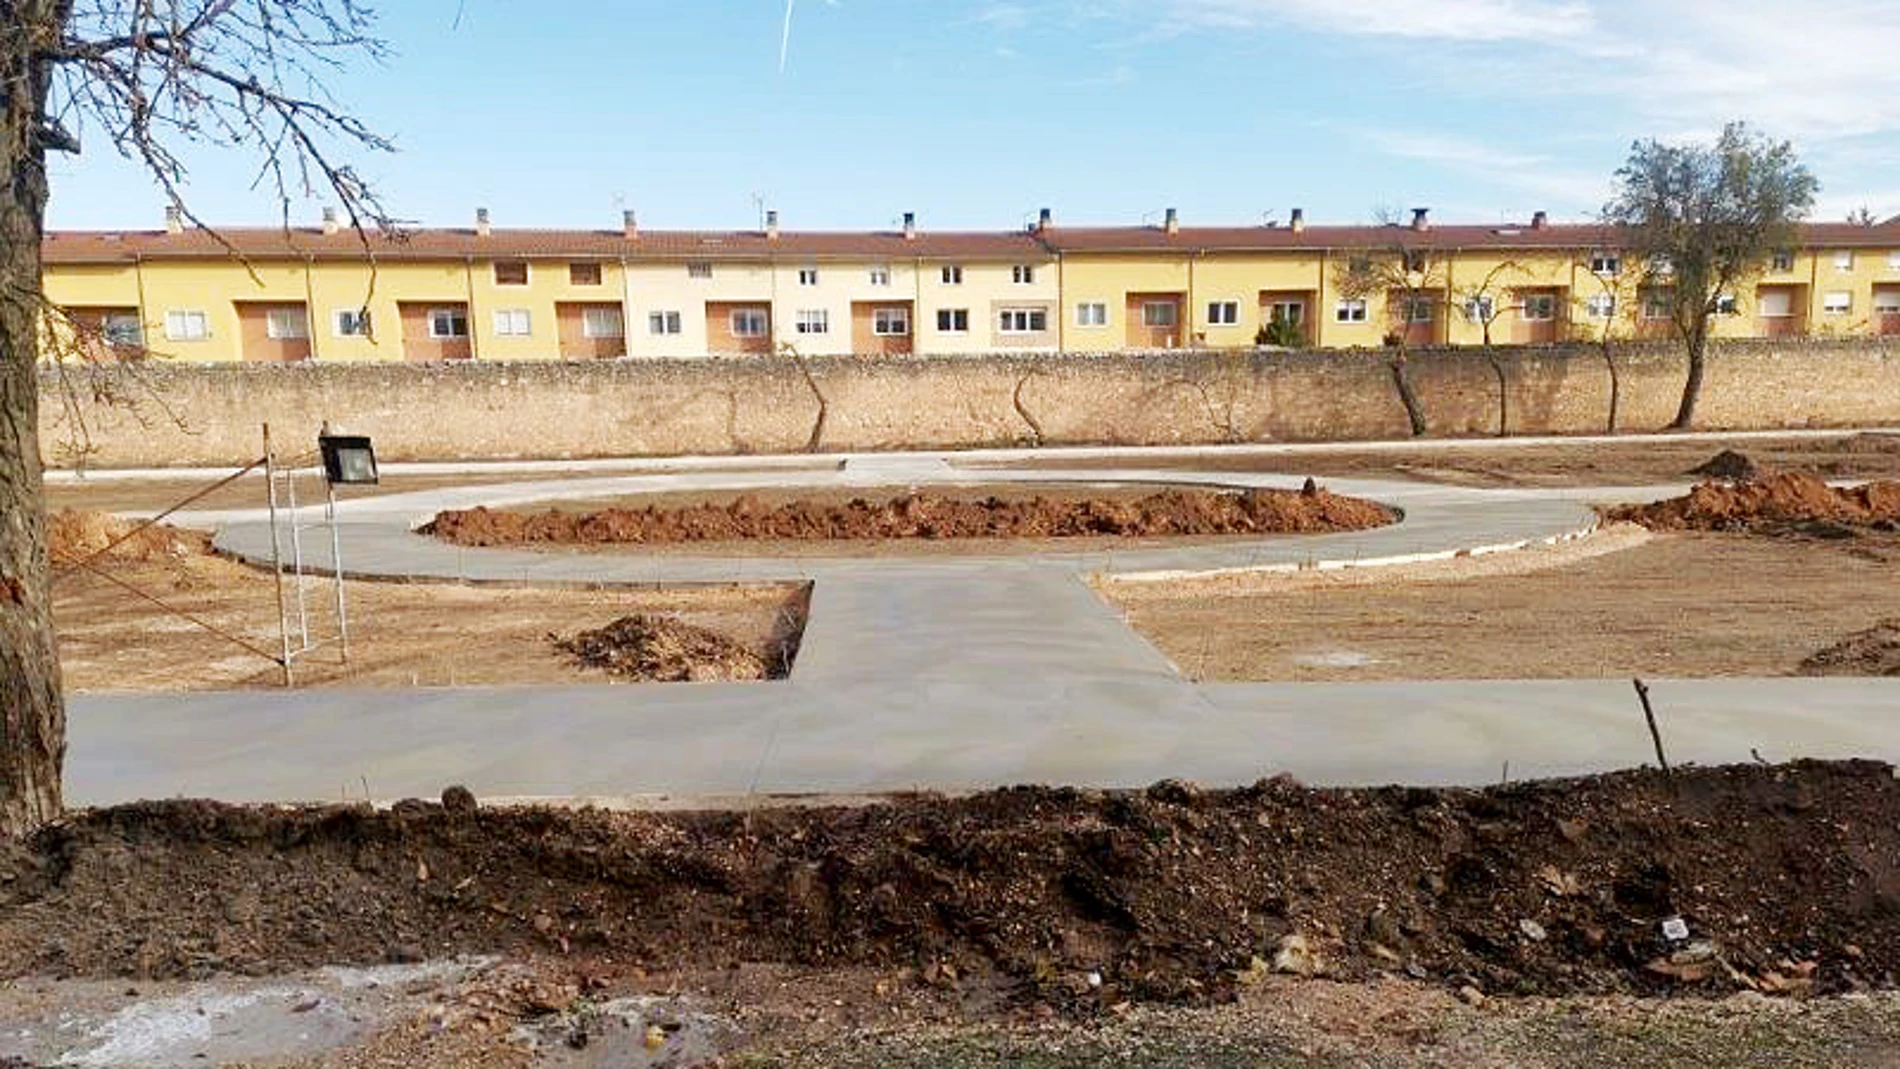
<box><xmin>547</xmin><ymin>613</ymin><xmax>775</xmax><ymax>684</ymax></box>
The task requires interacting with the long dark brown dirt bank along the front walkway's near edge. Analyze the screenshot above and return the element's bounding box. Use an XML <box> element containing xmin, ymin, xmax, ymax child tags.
<box><xmin>0</xmin><ymin>754</ymin><xmax>1900</xmax><ymax>1014</ymax></box>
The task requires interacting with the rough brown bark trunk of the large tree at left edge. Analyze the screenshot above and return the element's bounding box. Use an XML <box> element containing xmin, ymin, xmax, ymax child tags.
<box><xmin>0</xmin><ymin>0</ymin><xmax>67</xmax><ymax>837</ymax></box>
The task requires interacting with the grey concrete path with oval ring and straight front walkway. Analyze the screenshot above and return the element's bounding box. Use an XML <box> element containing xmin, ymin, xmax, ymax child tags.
<box><xmin>68</xmin><ymin>454</ymin><xmax>1900</xmax><ymax>803</ymax></box>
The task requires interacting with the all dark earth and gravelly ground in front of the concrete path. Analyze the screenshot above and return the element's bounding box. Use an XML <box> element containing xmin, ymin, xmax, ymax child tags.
<box><xmin>0</xmin><ymin>761</ymin><xmax>1900</xmax><ymax>1067</ymax></box>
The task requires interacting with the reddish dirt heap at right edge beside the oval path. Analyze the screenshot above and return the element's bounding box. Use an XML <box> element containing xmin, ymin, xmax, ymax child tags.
<box><xmin>1604</xmin><ymin>473</ymin><xmax>1900</xmax><ymax>534</ymax></box>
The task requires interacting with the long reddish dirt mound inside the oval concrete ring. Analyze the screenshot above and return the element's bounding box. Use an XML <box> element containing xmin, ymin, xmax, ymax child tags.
<box><xmin>422</xmin><ymin>486</ymin><xmax>1395</xmax><ymax>545</ymax></box>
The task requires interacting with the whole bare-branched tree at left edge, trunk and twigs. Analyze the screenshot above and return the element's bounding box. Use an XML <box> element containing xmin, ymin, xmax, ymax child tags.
<box><xmin>0</xmin><ymin>0</ymin><xmax>391</xmax><ymax>835</ymax></box>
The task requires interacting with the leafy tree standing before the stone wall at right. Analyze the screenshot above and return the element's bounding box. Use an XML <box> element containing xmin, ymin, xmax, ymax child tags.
<box><xmin>1604</xmin><ymin>122</ymin><xmax>1820</xmax><ymax>429</ymax></box>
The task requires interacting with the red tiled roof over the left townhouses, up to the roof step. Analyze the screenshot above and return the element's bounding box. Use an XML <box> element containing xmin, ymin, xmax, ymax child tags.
<box><xmin>40</xmin><ymin>228</ymin><xmax>1049</xmax><ymax>264</ymax></box>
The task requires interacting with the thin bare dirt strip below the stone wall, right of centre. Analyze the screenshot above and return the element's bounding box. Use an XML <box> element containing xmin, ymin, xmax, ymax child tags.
<box><xmin>973</xmin><ymin>433</ymin><xmax>1900</xmax><ymax>486</ymax></box>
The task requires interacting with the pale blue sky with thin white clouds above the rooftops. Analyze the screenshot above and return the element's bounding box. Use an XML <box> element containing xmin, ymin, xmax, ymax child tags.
<box><xmin>49</xmin><ymin>0</ymin><xmax>1900</xmax><ymax>230</ymax></box>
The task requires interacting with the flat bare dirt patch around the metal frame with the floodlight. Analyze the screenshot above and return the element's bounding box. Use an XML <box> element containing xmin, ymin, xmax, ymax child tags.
<box><xmin>53</xmin><ymin>520</ymin><xmax>806</xmax><ymax>691</ymax></box>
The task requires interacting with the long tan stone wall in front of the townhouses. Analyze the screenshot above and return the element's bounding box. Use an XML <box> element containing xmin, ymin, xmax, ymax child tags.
<box><xmin>42</xmin><ymin>340</ymin><xmax>1900</xmax><ymax>467</ymax></box>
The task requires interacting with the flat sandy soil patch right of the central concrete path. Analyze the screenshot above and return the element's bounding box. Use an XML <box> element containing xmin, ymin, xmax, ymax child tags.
<box><xmin>1104</xmin><ymin>530</ymin><xmax>1900</xmax><ymax>682</ymax></box>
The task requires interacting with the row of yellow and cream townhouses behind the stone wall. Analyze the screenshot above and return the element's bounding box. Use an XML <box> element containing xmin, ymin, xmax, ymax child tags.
<box><xmin>42</xmin><ymin>211</ymin><xmax>1900</xmax><ymax>361</ymax></box>
